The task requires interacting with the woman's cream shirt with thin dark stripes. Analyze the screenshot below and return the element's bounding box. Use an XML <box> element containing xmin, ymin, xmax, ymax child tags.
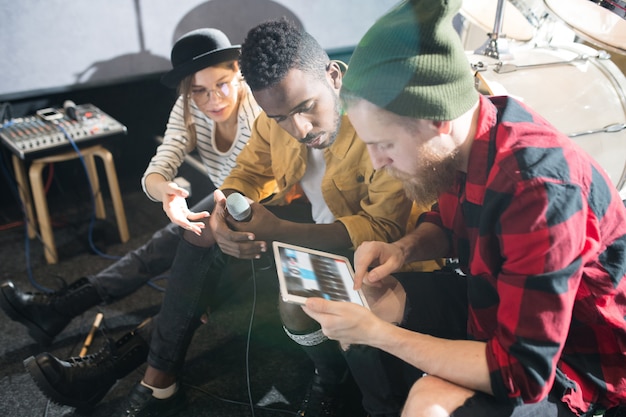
<box><xmin>141</xmin><ymin>84</ymin><xmax>261</xmax><ymax>200</ymax></box>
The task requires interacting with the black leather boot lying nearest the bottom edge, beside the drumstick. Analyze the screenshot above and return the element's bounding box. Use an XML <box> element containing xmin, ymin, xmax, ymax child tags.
<box><xmin>24</xmin><ymin>322</ymin><xmax>149</xmax><ymax>409</ymax></box>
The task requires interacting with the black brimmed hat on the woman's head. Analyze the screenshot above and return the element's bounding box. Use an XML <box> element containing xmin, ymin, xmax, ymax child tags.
<box><xmin>161</xmin><ymin>29</ymin><xmax>241</xmax><ymax>88</ymax></box>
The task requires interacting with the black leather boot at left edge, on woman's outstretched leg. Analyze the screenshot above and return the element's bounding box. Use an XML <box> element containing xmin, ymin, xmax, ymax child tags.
<box><xmin>0</xmin><ymin>278</ymin><xmax>102</xmax><ymax>345</ymax></box>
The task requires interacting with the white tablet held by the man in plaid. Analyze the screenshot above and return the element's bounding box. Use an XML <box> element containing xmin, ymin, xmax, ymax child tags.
<box><xmin>273</xmin><ymin>241</ymin><xmax>369</xmax><ymax>308</ymax></box>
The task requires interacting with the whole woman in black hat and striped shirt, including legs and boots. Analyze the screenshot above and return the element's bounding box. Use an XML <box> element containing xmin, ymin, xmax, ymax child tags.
<box><xmin>14</xmin><ymin>29</ymin><xmax>260</xmax><ymax>408</ymax></box>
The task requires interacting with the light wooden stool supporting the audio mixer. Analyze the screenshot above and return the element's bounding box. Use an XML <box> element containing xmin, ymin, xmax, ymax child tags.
<box><xmin>13</xmin><ymin>145</ymin><xmax>130</xmax><ymax>264</ymax></box>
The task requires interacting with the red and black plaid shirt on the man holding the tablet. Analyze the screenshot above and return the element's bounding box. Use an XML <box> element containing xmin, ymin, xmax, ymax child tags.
<box><xmin>421</xmin><ymin>97</ymin><xmax>626</xmax><ymax>413</ymax></box>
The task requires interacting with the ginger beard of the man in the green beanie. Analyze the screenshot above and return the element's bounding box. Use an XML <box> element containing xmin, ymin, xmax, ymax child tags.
<box><xmin>385</xmin><ymin>150</ymin><xmax>458</xmax><ymax>206</ymax></box>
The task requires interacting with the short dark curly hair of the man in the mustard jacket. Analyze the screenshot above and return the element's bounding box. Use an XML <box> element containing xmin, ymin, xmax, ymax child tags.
<box><xmin>239</xmin><ymin>18</ymin><xmax>330</xmax><ymax>91</ymax></box>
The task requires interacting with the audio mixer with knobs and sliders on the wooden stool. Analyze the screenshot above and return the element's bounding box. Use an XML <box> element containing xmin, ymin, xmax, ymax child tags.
<box><xmin>0</xmin><ymin>104</ymin><xmax>126</xmax><ymax>159</ymax></box>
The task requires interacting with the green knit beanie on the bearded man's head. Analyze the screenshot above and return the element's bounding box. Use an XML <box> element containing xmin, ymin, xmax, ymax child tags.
<box><xmin>343</xmin><ymin>0</ymin><xmax>478</xmax><ymax>121</ymax></box>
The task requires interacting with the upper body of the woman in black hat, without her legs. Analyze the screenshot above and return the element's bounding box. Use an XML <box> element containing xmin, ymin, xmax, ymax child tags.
<box><xmin>142</xmin><ymin>29</ymin><xmax>259</xmax><ymax>234</ymax></box>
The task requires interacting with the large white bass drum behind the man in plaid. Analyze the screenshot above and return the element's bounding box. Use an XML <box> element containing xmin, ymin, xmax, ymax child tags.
<box><xmin>468</xmin><ymin>43</ymin><xmax>626</xmax><ymax>192</ymax></box>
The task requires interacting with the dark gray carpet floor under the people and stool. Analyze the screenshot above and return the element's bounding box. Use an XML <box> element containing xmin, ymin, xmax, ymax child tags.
<box><xmin>0</xmin><ymin>184</ymin><xmax>362</xmax><ymax>417</ymax></box>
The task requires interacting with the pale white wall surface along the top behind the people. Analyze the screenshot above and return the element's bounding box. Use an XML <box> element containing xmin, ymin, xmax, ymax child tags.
<box><xmin>0</xmin><ymin>0</ymin><xmax>398</xmax><ymax>101</ymax></box>
